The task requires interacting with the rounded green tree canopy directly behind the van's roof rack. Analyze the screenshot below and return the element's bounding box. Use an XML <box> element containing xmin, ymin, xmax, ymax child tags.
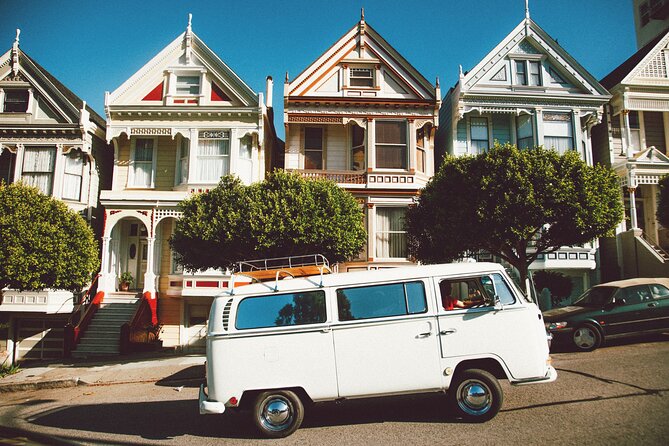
<box><xmin>170</xmin><ymin>170</ymin><xmax>366</xmax><ymax>270</ymax></box>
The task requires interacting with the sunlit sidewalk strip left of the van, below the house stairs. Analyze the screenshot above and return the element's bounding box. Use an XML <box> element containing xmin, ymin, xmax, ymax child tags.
<box><xmin>0</xmin><ymin>353</ymin><xmax>205</xmax><ymax>394</ymax></box>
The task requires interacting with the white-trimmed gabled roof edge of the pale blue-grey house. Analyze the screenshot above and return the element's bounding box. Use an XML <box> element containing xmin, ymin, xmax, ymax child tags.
<box><xmin>459</xmin><ymin>14</ymin><xmax>609</xmax><ymax>96</ymax></box>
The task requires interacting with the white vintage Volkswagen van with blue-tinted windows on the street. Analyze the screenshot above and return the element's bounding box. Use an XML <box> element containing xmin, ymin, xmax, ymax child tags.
<box><xmin>199</xmin><ymin>263</ymin><xmax>557</xmax><ymax>437</ymax></box>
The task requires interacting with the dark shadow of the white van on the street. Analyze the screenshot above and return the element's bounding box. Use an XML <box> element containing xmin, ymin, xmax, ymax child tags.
<box><xmin>31</xmin><ymin>394</ymin><xmax>468</xmax><ymax>440</ymax></box>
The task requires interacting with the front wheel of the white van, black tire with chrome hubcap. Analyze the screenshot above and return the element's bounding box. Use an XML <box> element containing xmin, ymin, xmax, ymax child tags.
<box><xmin>448</xmin><ymin>369</ymin><xmax>504</xmax><ymax>423</ymax></box>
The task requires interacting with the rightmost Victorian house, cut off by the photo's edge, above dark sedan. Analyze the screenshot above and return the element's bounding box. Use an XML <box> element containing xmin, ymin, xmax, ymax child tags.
<box><xmin>593</xmin><ymin>31</ymin><xmax>669</xmax><ymax>279</ymax></box>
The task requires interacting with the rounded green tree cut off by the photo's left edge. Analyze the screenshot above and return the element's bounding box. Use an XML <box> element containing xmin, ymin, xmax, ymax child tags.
<box><xmin>0</xmin><ymin>183</ymin><xmax>100</xmax><ymax>293</ymax></box>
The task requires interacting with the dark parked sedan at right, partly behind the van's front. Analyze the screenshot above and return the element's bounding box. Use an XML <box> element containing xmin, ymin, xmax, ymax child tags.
<box><xmin>543</xmin><ymin>278</ymin><xmax>669</xmax><ymax>351</ymax></box>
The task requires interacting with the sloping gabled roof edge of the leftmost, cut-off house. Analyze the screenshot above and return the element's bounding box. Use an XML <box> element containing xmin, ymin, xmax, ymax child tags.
<box><xmin>0</xmin><ymin>35</ymin><xmax>105</xmax><ymax>128</ymax></box>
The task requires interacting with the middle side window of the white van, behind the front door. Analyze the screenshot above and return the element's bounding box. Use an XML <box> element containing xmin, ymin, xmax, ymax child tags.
<box><xmin>337</xmin><ymin>282</ymin><xmax>427</xmax><ymax>321</ymax></box>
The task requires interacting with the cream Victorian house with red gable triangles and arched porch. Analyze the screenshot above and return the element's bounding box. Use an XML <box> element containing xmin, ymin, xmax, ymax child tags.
<box><xmin>87</xmin><ymin>19</ymin><xmax>274</xmax><ymax>354</ymax></box>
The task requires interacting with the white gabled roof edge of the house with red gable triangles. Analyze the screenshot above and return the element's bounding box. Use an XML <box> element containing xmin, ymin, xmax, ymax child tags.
<box><xmin>106</xmin><ymin>23</ymin><xmax>259</xmax><ymax>107</ymax></box>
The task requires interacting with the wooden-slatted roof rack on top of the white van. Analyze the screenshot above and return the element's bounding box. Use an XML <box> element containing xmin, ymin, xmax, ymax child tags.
<box><xmin>230</xmin><ymin>254</ymin><xmax>332</xmax><ymax>295</ymax></box>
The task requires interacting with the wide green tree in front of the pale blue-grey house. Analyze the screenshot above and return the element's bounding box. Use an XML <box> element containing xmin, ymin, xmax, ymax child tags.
<box><xmin>407</xmin><ymin>144</ymin><xmax>623</xmax><ymax>283</ymax></box>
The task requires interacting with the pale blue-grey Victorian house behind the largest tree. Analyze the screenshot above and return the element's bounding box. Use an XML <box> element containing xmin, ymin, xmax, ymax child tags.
<box><xmin>437</xmin><ymin>10</ymin><xmax>610</xmax><ymax>295</ymax></box>
